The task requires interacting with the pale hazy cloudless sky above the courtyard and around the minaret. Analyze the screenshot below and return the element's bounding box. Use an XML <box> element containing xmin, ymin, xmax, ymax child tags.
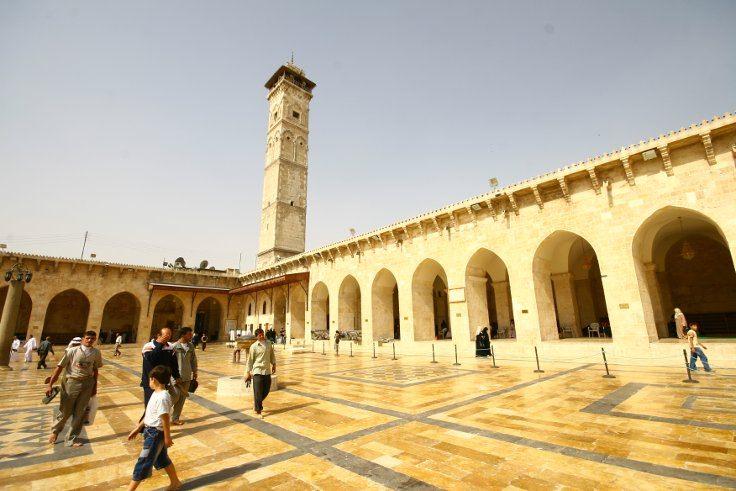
<box><xmin>0</xmin><ymin>0</ymin><xmax>736</xmax><ymax>270</ymax></box>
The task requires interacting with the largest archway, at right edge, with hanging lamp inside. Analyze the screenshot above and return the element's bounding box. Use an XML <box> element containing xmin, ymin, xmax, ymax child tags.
<box><xmin>633</xmin><ymin>207</ymin><xmax>736</xmax><ymax>339</ymax></box>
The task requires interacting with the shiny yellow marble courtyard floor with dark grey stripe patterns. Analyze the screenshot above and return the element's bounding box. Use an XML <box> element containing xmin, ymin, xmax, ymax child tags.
<box><xmin>0</xmin><ymin>345</ymin><xmax>736</xmax><ymax>490</ymax></box>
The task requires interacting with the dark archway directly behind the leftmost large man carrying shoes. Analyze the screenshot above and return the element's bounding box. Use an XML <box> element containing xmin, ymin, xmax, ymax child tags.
<box><xmin>42</xmin><ymin>289</ymin><xmax>89</xmax><ymax>344</ymax></box>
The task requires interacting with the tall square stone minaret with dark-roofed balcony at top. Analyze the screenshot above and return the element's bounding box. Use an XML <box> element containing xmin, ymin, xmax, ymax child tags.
<box><xmin>257</xmin><ymin>63</ymin><xmax>316</xmax><ymax>267</ymax></box>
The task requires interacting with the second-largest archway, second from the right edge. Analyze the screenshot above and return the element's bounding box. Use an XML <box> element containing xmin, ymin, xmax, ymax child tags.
<box><xmin>533</xmin><ymin>230</ymin><xmax>611</xmax><ymax>340</ymax></box>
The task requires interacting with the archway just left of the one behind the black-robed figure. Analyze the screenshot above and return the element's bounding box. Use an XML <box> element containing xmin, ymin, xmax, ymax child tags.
<box><xmin>412</xmin><ymin>259</ymin><xmax>452</xmax><ymax>341</ymax></box>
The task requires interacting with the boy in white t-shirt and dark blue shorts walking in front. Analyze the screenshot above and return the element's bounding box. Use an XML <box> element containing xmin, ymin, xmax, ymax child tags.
<box><xmin>128</xmin><ymin>365</ymin><xmax>181</xmax><ymax>490</ymax></box>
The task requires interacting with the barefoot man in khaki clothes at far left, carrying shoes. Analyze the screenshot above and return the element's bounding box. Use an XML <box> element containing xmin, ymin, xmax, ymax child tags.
<box><xmin>46</xmin><ymin>331</ymin><xmax>102</xmax><ymax>447</ymax></box>
